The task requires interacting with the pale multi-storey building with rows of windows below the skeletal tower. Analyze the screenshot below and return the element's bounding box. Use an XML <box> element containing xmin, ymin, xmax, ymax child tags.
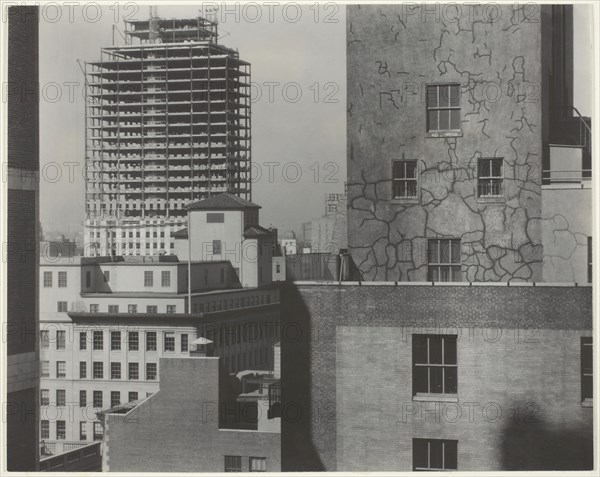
<box><xmin>39</xmin><ymin>192</ymin><xmax>280</xmax><ymax>454</ymax></box>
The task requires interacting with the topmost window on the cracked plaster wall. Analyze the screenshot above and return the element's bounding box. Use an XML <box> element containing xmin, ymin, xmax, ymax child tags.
<box><xmin>427</xmin><ymin>84</ymin><xmax>460</xmax><ymax>132</ymax></box>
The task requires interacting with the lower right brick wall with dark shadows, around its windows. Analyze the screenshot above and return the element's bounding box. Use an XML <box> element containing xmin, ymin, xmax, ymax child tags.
<box><xmin>281</xmin><ymin>283</ymin><xmax>592</xmax><ymax>471</ymax></box>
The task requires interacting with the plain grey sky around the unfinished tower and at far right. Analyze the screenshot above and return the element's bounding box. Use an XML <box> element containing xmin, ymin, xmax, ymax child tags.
<box><xmin>40</xmin><ymin>2</ymin><xmax>593</xmax><ymax>242</ymax></box>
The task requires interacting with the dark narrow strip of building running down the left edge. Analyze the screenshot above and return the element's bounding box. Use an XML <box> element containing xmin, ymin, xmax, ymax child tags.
<box><xmin>6</xmin><ymin>6</ymin><xmax>39</xmax><ymax>471</ymax></box>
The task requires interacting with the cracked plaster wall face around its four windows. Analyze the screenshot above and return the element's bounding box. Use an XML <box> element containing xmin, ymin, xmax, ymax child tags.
<box><xmin>346</xmin><ymin>5</ymin><xmax>545</xmax><ymax>281</ymax></box>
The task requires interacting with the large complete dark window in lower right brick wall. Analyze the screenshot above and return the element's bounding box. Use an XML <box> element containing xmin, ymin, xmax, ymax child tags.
<box><xmin>412</xmin><ymin>334</ymin><xmax>457</xmax><ymax>396</ymax></box>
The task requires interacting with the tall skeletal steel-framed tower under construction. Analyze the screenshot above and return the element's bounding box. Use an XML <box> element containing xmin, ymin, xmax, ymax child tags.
<box><xmin>85</xmin><ymin>13</ymin><xmax>252</xmax><ymax>255</ymax></box>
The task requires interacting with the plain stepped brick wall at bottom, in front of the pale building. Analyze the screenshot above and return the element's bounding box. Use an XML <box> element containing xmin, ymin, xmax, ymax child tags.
<box><xmin>104</xmin><ymin>358</ymin><xmax>281</xmax><ymax>472</ymax></box>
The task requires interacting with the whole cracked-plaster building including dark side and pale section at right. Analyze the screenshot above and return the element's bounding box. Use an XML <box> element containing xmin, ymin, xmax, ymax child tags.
<box><xmin>347</xmin><ymin>5</ymin><xmax>591</xmax><ymax>283</ymax></box>
